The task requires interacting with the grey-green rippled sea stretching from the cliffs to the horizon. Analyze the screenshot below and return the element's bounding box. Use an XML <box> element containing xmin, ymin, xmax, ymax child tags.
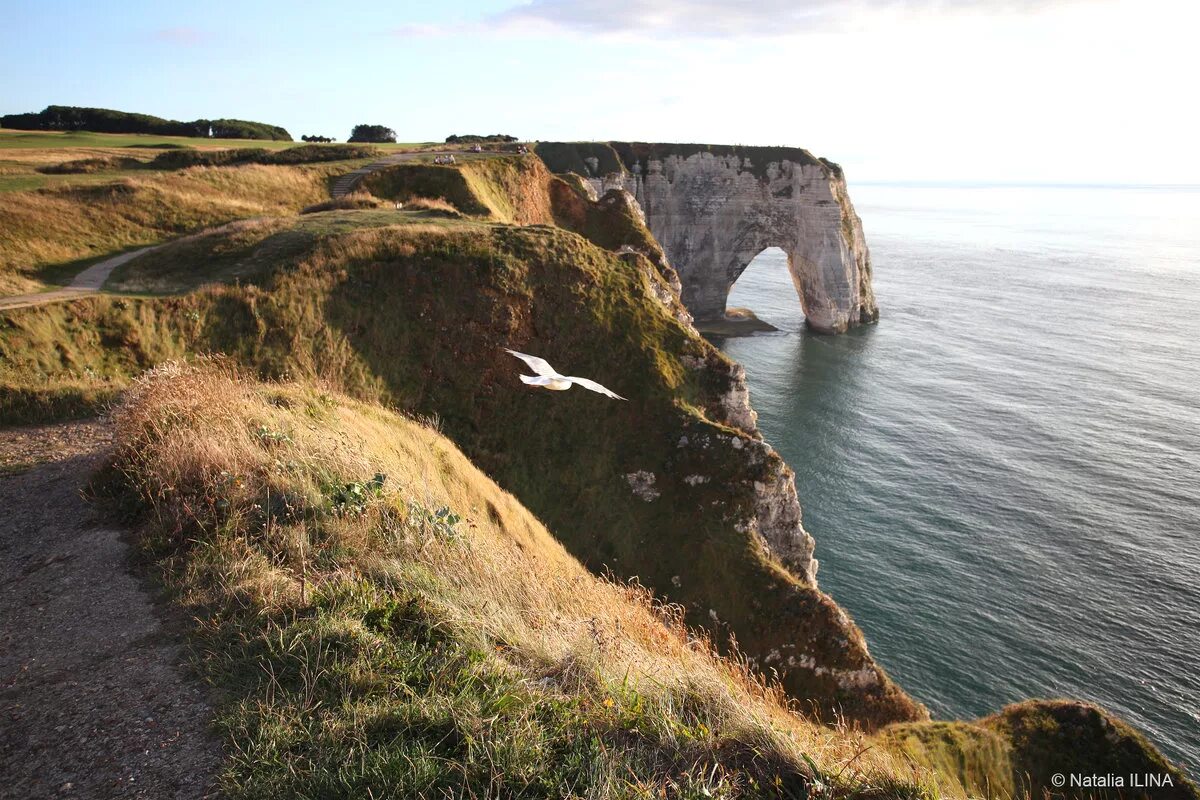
<box><xmin>718</xmin><ymin>185</ymin><xmax>1200</xmax><ymax>775</ymax></box>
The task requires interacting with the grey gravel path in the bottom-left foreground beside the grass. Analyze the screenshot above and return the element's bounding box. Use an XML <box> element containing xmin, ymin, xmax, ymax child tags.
<box><xmin>0</xmin><ymin>421</ymin><xmax>221</xmax><ymax>800</ymax></box>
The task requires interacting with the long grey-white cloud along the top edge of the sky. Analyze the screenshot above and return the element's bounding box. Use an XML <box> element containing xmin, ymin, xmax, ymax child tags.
<box><xmin>395</xmin><ymin>0</ymin><xmax>1094</xmax><ymax>38</ymax></box>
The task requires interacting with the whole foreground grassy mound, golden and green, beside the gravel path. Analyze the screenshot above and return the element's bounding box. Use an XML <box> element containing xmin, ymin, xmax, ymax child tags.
<box><xmin>98</xmin><ymin>362</ymin><xmax>936</xmax><ymax>798</ymax></box>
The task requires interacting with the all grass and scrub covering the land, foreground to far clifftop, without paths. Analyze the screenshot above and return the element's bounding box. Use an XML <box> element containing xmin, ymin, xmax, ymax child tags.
<box><xmin>0</xmin><ymin>131</ymin><xmax>1200</xmax><ymax>800</ymax></box>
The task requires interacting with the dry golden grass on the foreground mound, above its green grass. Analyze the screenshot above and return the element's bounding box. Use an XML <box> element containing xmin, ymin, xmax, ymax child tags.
<box><xmin>114</xmin><ymin>362</ymin><xmax>962</xmax><ymax>795</ymax></box>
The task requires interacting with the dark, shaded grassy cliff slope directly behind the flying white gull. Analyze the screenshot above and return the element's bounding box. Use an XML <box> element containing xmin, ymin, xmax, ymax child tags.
<box><xmin>0</xmin><ymin>205</ymin><xmax>920</xmax><ymax>726</ymax></box>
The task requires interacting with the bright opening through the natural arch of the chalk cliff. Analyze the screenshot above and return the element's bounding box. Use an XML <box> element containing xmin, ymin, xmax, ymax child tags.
<box><xmin>722</xmin><ymin>247</ymin><xmax>805</xmax><ymax>333</ymax></box>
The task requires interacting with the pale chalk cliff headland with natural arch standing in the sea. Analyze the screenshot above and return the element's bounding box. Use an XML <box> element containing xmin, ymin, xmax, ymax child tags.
<box><xmin>538</xmin><ymin>142</ymin><xmax>878</xmax><ymax>333</ymax></box>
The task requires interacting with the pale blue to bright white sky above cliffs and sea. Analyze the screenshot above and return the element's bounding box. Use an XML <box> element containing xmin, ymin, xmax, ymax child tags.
<box><xmin>0</xmin><ymin>0</ymin><xmax>1200</xmax><ymax>184</ymax></box>
